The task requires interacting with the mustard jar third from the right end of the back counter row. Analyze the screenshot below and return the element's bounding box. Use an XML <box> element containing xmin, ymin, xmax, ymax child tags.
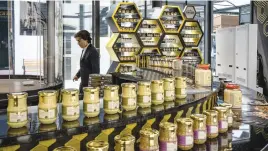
<box><xmin>151</xmin><ymin>80</ymin><xmax>164</xmax><ymax>105</ymax></box>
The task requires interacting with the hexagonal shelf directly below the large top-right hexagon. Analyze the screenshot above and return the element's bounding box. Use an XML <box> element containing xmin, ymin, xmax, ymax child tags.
<box><xmin>160</xmin><ymin>34</ymin><xmax>184</xmax><ymax>57</ymax></box>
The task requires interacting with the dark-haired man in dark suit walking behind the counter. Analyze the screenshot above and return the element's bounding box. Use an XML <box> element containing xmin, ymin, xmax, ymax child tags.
<box><xmin>73</xmin><ymin>30</ymin><xmax>100</xmax><ymax>93</ymax></box>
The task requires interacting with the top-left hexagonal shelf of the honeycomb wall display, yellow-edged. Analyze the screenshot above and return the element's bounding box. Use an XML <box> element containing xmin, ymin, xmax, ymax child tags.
<box><xmin>106</xmin><ymin>2</ymin><xmax>142</xmax><ymax>32</ymax></box>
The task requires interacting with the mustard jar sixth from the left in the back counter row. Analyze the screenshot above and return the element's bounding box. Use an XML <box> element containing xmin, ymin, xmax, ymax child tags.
<box><xmin>121</xmin><ymin>83</ymin><xmax>137</xmax><ymax>111</ymax></box>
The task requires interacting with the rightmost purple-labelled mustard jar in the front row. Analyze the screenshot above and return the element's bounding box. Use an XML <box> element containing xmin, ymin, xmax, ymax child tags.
<box><xmin>214</xmin><ymin>106</ymin><xmax>228</xmax><ymax>133</ymax></box>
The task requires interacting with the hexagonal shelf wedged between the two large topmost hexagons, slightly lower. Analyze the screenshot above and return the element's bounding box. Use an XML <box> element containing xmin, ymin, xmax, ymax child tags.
<box><xmin>137</xmin><ymin>19</ymin><xmax>163</xmax><ymax>46</ymax></box>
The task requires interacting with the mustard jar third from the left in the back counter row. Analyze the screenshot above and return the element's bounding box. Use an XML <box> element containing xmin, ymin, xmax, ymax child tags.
<box><xmin>61</xmin><ymin>89</ymin><xmax>80</xmax><ymax>121</ymax></box>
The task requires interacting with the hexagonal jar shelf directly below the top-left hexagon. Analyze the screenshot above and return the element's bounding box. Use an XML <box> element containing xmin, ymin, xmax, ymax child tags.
<box><xmin>106</xmin><ymin>33</ymin><xmax>141</xmax><ymax>62</ymax></box>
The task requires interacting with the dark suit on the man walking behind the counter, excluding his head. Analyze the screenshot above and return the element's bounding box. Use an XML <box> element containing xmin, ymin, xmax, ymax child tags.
<box><xmin>76</xmin><ymin>44</ymin><xmax>100</xmax><ymax>92</ymax></box>
